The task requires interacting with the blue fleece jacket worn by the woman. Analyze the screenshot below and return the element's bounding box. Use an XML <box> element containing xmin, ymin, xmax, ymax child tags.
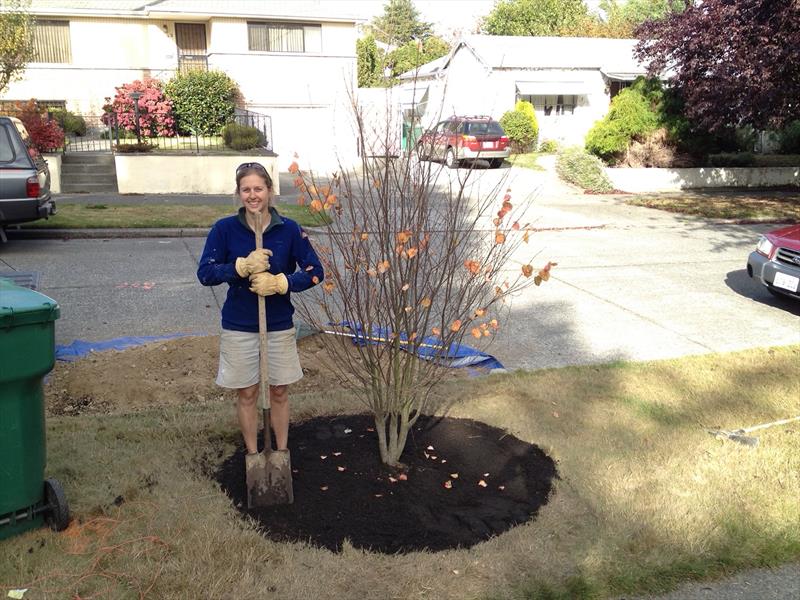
<box><xmin>197</xmin><ymin>208</ymin><xmax>324</xmax><ymax>332</ymax></box>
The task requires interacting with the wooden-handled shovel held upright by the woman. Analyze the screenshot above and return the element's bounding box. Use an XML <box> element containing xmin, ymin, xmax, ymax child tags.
<box><xmin>246</xmin><ymin>213</ymin><xmax>294</xmax><ymax>508</ymax></box>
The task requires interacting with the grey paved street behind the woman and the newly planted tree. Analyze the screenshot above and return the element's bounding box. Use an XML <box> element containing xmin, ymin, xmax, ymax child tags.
<box><xmin>0</xmin><ymin>162</ymin><xmax>800</xmax><ymax>369</ymax></box>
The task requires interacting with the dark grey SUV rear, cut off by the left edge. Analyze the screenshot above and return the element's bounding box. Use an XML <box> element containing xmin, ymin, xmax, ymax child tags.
<box><xmin>0</xmin><ymin>116</ymin><xmax>56</xmax><ymax>241</ymax></box>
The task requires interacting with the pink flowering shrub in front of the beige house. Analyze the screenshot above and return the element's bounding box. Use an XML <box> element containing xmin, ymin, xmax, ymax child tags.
<box><xmin>103</xmin><ymin>77</ymin><xmax>175</xmax><ymax>137</ymax></box>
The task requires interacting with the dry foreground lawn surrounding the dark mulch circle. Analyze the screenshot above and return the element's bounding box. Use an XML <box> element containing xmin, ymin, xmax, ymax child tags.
<box><xmin>0</xmin><ymin>346</ymin><xmax>800</xmax><ymax>600</ymax></box>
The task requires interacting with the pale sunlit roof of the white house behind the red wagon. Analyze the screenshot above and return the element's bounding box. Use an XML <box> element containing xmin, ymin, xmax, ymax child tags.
<box><xmin>402</xmin><ymin>35</ymin><xmax>645</xmax><ymax>79</ymax></box>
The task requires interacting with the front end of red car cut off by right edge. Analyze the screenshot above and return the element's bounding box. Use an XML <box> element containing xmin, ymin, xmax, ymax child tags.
<box><xmin>747</xmin><ymin>225</ymin><xmax>800</xmax><ymax>299</ymax></box>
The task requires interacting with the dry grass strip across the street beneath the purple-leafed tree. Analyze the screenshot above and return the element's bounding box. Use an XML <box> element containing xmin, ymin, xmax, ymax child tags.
<box><xmin>624</xmin><ymin>190</ymin><xmax>800</xmax><ymax>223</ymax></box>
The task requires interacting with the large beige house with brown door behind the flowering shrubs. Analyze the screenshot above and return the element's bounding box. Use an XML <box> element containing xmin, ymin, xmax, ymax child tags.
<box><xmin>0</xmin><ymin>0</ymin><xmax>360</xmax><ymax>167</ymax></box>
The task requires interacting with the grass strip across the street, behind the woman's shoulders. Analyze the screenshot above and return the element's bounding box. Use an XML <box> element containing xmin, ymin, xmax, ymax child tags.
<box><xmin>22</xmin><ymin>203</ymin><xmax>328</xmax><ymax>229</ymax></box>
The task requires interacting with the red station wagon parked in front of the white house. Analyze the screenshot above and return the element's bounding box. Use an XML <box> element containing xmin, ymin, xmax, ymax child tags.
<box><xmin>417</xmin><ymin>116</ymin><xmax>511</xmax><ymax>169</ymax></box>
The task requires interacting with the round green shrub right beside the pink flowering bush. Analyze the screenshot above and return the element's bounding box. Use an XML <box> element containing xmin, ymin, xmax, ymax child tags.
<box><xmin>164</xmin><ymin>70</ymin><xmax>239</xmax><ymax>135</ymax></box>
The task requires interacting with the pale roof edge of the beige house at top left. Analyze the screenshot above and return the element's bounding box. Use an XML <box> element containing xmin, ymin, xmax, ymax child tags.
<box><xmin>22</xmin><ymin>0</ymin><xmax>364</xmax><ymax>23</ymax></box>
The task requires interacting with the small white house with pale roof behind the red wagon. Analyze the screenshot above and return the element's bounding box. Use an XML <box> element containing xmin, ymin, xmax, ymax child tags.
<box><xmin>401</xmin><ymin>35</ymin><xmax>645</xmax><ymax>144</ymax></box>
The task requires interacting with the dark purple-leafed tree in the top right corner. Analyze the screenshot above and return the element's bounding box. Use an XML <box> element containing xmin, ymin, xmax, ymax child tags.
<box><xmin>635</xmin><ymin>0</ymin><xmax>800</xmax><ymax>131</ymax></box>
